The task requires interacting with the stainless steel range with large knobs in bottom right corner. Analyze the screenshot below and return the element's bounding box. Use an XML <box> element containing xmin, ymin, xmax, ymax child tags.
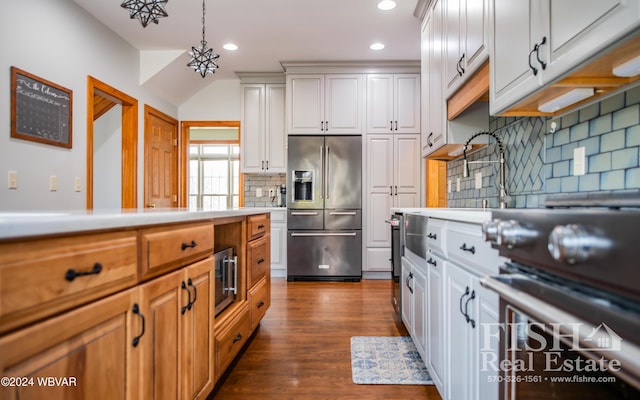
<box><xmin>482</xmin><ymin>191</ymin><xmax>640</xmax><ymax>399</ymax></box>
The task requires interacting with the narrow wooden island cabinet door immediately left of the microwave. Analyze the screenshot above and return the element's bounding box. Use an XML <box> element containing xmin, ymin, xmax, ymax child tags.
<box><xmin>180</xmin><ymin>257</ymin><xmax>215</xmax><ymax>399</ymax></box>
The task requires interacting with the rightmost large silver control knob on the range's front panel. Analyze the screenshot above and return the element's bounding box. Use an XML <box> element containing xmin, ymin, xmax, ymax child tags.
<box><xmin>547</xmin><ymin>224</ymin><xmax>611</xmax><ymax>264</ymax></box>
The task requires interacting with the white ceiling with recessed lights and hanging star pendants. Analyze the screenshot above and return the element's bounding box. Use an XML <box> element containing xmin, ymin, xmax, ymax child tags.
<box><xmin>73</xmin><ymin>0</ymin><xmax>420</xmax><ymax>105</ymax></box>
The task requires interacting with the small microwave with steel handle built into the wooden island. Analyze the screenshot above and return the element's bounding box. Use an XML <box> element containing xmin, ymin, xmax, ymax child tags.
<box><xmin>213</xmin><ymin>247</ymin><xmax>238</xmax><ymax>315</ymax></box>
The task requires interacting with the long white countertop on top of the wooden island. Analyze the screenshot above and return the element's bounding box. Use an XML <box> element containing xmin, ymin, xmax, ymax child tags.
<box><xmin>0</xmin><ymin>207</ymin><xmax>276</xmax><ymax>240</ymax></box>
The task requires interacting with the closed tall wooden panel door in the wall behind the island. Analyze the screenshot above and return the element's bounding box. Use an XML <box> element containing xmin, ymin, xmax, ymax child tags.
<box><xmin>144</xmin><ymin>105</ymin><xmax>178</xmax><ymax>208</ymax></box>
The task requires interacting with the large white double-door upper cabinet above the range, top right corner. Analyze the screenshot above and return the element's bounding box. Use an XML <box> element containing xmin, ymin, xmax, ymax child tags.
<box><xmin>490</xmin><ymin>0</ymin><xmax>640</xmax><ymax>115</ymax></box>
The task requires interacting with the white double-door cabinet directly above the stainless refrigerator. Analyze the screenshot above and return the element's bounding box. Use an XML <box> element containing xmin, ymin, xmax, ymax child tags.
<box><xmin>286</xmin><ymin>74</ymin><xmax>365</xmax><ymax>134</ymax></box>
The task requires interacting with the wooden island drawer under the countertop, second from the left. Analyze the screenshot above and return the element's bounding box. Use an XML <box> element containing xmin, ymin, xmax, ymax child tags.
<box><xmin>140</xmin><ymin>222</ymin><xmax>213</xmax><ymax>280</ymax></box>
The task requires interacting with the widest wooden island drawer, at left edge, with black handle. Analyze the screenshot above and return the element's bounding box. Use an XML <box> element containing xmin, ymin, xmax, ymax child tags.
<box><xmin>0</xmin><ymin>231</ymin><xmax>138</xmax><ymax>332</ymax></box>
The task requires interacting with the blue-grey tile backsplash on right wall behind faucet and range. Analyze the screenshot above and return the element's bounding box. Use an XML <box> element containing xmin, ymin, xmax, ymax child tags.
<box><xmin>447</xmin><ymin>86</ymin><xmax>640</xmax><ymax>208</ymax></box>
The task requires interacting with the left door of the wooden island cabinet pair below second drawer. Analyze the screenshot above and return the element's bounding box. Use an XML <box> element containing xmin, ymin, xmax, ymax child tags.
<box><xmin>137</xmin><ymin>271</ymin><xmax>182</xmax><ymax>400</ymax></box>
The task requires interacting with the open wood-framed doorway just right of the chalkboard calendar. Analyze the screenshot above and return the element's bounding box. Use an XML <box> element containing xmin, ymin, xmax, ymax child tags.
<box><xmin>86</xmin><ymin>76</ymin><xmax>138</xmax><ymax>210</ymax></box>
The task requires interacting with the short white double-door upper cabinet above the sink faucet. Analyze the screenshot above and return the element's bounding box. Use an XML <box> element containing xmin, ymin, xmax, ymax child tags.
<box><xmin>444</xmin><ymin>0</ymin><xmax>490</xmax><ymax>98</ymax></box>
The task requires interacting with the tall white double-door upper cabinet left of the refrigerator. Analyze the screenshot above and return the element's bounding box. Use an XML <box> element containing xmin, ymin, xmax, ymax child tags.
<box><xmin>240</xmin><ymin>84</ymin><xmax>287</xmax><ymax>174</ymax></box>
